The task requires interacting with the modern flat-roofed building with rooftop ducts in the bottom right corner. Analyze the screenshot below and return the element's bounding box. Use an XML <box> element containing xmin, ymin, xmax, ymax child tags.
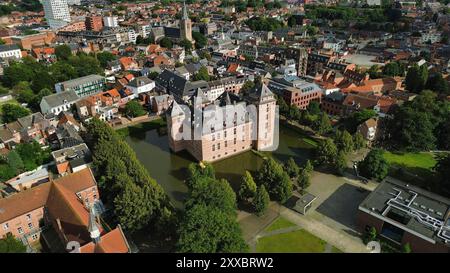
<box><xmin>357</xmin><ymin>177</ymin><xmax>450</xmax><ymax>253</ymax></box>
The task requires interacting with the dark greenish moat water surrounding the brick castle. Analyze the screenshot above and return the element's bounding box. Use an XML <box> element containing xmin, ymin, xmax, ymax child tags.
<box><xmin>126</xmin><ymin>122</ymin><xmax>313</xmax><ymax>207</ymax></box>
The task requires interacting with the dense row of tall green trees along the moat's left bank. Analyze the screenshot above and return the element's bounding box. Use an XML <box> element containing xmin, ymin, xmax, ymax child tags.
<box><xmin>84</xmin><ymin>118</ymin><xmax>174</xmax><ymax>231</ymax></box>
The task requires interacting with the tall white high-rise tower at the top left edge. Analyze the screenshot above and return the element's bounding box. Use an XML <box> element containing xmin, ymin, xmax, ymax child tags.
<box><xmin>42</xmin><ymin>0</ymin><xmax>70</xmax><ymax>29</ymax></box>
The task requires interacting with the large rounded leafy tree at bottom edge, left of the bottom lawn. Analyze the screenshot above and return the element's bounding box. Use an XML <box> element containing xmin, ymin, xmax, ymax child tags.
<box><xmin>177</xmin><ymin>204</ymin><xmax>248</xmax><ymax>253</ymax></box>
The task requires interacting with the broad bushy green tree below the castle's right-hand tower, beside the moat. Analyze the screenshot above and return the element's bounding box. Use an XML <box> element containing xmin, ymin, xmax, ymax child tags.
<box><xmin>257</xmin><ymin>158</ymin><xmax>292</xmax><ymax>203</ymax></box>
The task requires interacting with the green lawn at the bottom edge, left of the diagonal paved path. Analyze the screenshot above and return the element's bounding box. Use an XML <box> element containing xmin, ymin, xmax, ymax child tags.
<box><xmin>256</xmin><ymin>229</ymin><xmax>326</xmax><ymax>253</ymax></box>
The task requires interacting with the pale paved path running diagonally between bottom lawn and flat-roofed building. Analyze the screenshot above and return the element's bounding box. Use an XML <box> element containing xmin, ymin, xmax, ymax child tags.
<box><xmin>281</xmin><ymin>207</ymin><xmax>369</xmax><ymax>253</ymax></box>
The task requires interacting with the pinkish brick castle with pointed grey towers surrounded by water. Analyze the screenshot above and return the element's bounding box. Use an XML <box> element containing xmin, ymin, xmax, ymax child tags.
<box><xmin>166</xmin><ymin>84</ymin><xmax>277</xmax><ymax>162</ymax></box>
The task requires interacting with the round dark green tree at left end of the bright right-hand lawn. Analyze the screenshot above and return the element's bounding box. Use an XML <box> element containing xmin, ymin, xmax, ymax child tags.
<box><xmin>358</xmin><ymin>149</ymin><xmax>389</xmax><ymax>181</ymax></box>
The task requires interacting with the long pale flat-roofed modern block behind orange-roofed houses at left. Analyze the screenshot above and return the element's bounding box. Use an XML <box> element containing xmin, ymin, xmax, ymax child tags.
<box><xmin>55</xmin><ymin>75</ymin><xmax>105</xmax><ymax>98</ymax></box>
